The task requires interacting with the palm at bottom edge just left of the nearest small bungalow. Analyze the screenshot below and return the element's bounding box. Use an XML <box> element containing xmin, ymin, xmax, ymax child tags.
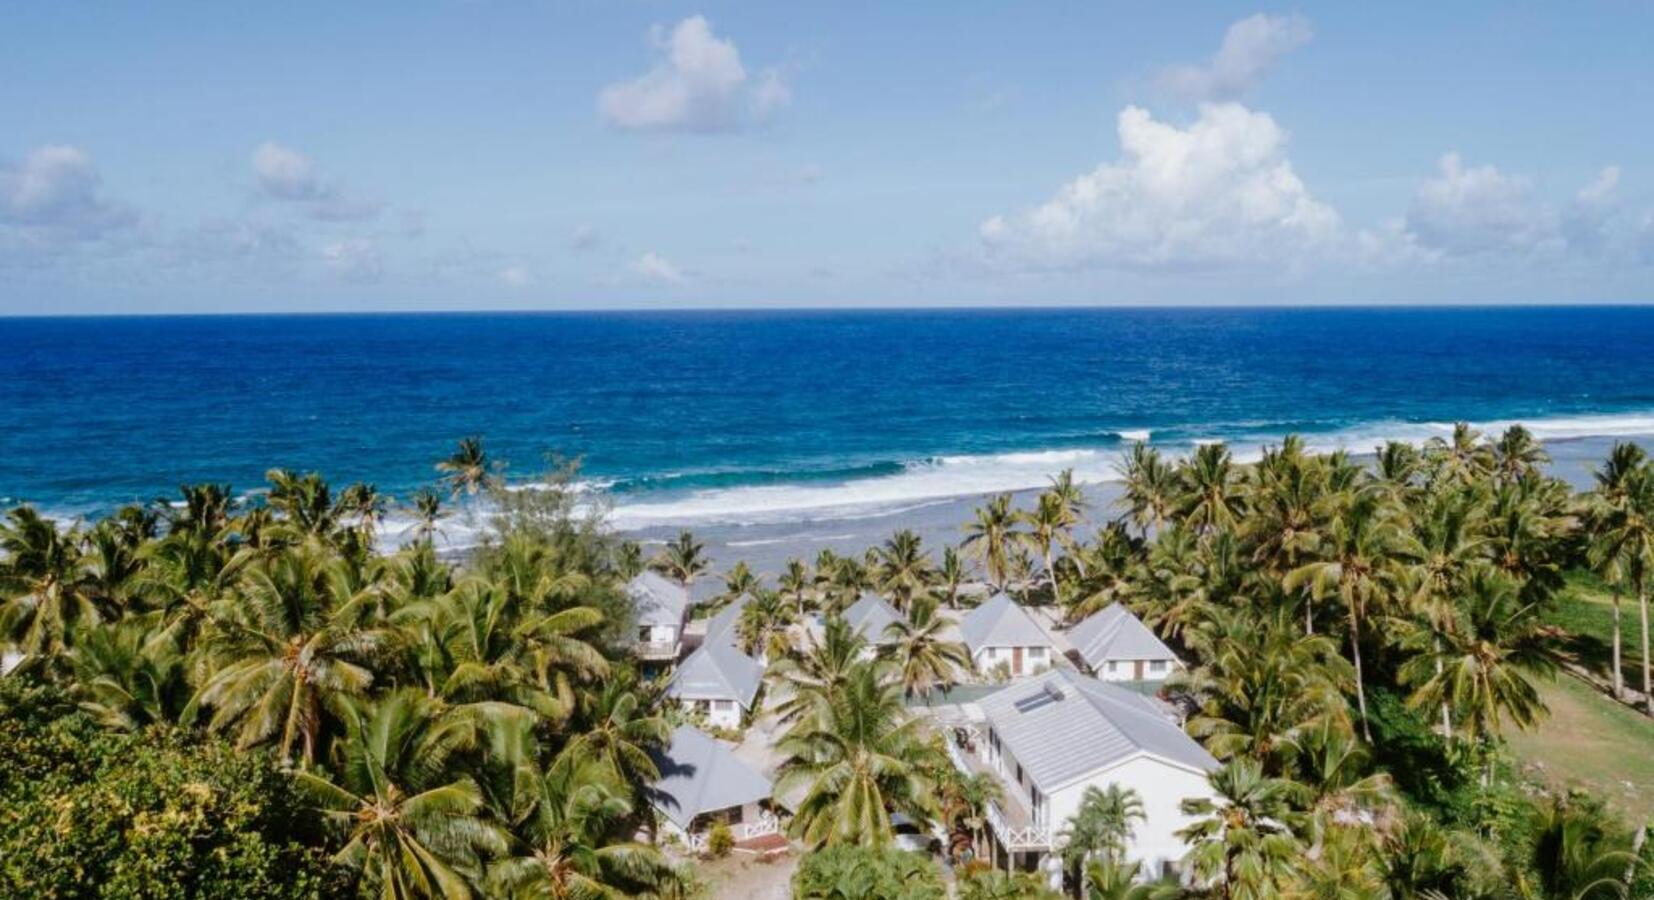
<box><xmin>488</xmin><ymin>749</ymin><xmax>680</xmax><ymax>900</ymax></box>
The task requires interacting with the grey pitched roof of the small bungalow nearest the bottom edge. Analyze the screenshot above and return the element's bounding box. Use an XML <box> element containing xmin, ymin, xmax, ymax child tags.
<box><xmin>648</xmin><ymin>725</ymin><xmax>772</xmax><ymax>829</ymax></box>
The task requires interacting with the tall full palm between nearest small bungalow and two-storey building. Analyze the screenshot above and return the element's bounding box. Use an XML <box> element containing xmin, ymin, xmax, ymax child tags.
<box><xmin>776</xmin><ymin>663</ymin><xmax>946</xmax><ymax>849</ymax></box>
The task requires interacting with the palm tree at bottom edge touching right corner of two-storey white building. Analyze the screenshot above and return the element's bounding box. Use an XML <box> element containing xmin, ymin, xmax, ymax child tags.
<box><xmin>1178</xmin><ymin>758</ymin><xmax>1302</xmax><ymax>900</ymax></box>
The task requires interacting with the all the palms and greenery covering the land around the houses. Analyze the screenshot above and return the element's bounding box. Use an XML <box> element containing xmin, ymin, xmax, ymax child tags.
<box><xmin>0</xmin><ymin>427</ymin><xmax>1654</xmax><ymax>900</ymax></box>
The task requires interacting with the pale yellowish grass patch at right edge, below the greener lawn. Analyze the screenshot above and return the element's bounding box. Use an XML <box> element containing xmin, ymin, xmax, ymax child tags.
<box><xmin>1510</xmin><ymin>675</ymin><xmax>1654</xmax><ymax>822</ymax></box>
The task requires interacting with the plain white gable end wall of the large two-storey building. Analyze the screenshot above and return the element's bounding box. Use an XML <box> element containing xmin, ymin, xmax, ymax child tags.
<box><xmin>1047</xmin><ymin>756</ymin><xmax>1216</xmax><ymax>874</ymax></box>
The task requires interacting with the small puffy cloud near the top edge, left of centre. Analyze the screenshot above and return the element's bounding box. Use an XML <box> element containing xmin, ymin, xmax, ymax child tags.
<box><xmin>597</xmin><ymin>15</ymin><xmax>792</xmax><ymax>132</ymax></box>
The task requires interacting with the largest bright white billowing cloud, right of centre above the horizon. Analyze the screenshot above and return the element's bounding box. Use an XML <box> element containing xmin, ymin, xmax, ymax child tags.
<box><xmin>979</xmin><ymin>104</ymin><xmax>1340</xmax><ymax>270</ymax></box>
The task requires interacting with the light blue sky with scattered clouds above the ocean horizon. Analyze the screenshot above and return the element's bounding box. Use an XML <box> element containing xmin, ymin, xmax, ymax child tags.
<box><xmin>0</xmin><ymin>0</ymin><xmax>1654</xmax><ymax>314</ymax></box>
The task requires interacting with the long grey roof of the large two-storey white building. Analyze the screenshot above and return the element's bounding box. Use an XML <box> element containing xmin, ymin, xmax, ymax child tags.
<box><xmin>978</xmin><ymin>668</ymin><xmax>1217</xmax><ymax>792</ymax></box>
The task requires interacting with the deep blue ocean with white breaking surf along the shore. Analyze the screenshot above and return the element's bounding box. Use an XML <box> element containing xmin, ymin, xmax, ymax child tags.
<box><xmin>0</xmin><ymin>308</ymin><xmax>1654</xmax><ymax>523</ymax></box>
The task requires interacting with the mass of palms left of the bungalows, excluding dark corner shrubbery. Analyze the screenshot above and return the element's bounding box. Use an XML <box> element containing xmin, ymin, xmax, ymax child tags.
<box><xmin>0</xmin><ymin>442</ymin><xmax>690</xmax><ymax>897</ymax></box>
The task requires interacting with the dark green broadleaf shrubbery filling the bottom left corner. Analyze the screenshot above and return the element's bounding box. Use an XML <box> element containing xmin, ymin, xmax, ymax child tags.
<box><xmin>0</xmin><ymin>678</ymin><xmax>347</xmax><ymax>900</ymax></box>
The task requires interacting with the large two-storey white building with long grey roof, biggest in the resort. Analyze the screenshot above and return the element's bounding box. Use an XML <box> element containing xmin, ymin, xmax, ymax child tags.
<box><xmin>943</xmin><ymin>668</ymin><xmax>1217</xmax><ymax>878</ymax></box>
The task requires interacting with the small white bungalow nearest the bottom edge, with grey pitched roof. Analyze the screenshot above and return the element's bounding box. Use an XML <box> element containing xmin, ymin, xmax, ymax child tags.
<box><xmin>648</xmin><ymin>725</ymin><xmax>781</xmax><ymax>850</ymax></box>
